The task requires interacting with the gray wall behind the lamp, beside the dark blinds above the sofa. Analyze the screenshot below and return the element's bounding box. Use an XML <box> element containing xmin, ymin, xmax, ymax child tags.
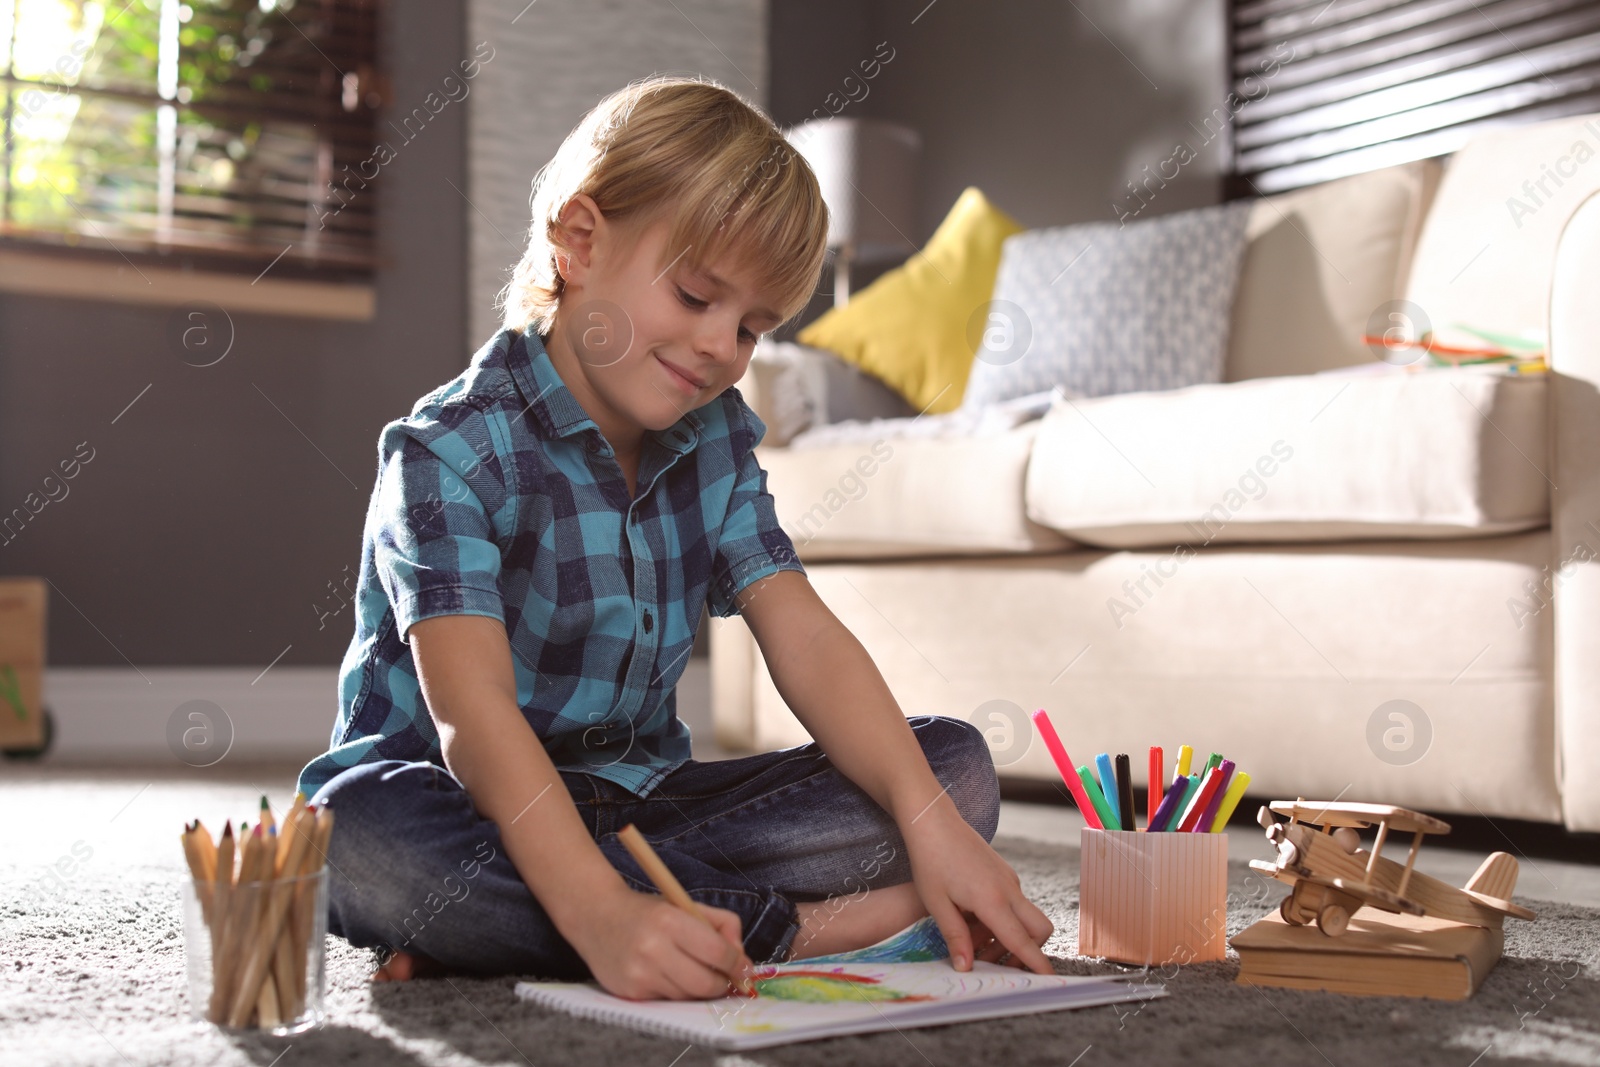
<box><xmin>770</xmin><ymin>0</ymin><xmax>1227</xmax><ymax>323</ymax></box>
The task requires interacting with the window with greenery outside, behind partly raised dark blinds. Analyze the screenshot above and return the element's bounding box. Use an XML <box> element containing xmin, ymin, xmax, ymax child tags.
<box><xmin>0</xmin><ymin>0</ymin><xmax>384</xmax><ymax>280</ymax></box>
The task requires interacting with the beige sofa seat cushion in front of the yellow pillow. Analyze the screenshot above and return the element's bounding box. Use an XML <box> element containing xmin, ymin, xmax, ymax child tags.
<box><xmin>757</xmin><ymin>419</ymin><xmax>1070</xmax><ymax>561</ymax></box>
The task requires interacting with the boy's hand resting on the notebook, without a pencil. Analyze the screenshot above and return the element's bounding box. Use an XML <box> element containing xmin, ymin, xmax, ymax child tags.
<box><xmin>901</xmin><ymin>803</ymin><xmax>1056</xmax><ymax>974</ymax></box>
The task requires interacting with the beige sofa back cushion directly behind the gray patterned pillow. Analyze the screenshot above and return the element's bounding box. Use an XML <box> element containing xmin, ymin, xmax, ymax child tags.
<box><xmin>1222</xmin><ymin>160</ymin><xmax>1440</xmax><ymax>382</ymax></box>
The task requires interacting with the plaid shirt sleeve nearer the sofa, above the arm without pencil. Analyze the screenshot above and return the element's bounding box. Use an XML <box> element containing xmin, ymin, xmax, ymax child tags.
<box><xmin>706</xmin><ymin>399</ymin><xmax>805</xmax><ymax>617</ymax></box>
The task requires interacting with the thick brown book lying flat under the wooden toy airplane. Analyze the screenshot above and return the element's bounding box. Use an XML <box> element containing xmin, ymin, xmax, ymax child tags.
<box><xmin>1232</xmin><ymin>907</ymin><xmax>1506</xmax><ymax>1000</ymax></box>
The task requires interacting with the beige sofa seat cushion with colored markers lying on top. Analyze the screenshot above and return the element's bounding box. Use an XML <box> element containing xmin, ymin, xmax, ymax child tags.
<box><xmin>1026</xmin><ymin>363</ymin><xmax>1550</xmax><ymax>547</ymax></box>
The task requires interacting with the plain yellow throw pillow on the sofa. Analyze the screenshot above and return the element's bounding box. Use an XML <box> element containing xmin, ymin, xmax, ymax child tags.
<box><xmin>798</xmin><ymin>187</ymin><xmax>1022</xmax><ymax>413</ymax></box>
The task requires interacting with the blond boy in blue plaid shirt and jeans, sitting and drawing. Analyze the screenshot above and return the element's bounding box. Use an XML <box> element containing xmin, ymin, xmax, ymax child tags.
<box><xmin>301</xmin><ymin>78</ymin><xmax>1051</xmax><ymax>998</ymax></box>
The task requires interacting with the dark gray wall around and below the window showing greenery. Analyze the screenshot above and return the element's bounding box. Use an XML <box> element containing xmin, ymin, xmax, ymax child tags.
<box><xmin>0</xmin><ymin>0</ymin><xmax>472</xmax><ymax>669</ymax></box>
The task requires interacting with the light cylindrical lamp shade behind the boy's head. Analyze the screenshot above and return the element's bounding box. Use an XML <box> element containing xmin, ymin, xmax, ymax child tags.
<box><xmin>787</xmin><ymin>118</ymin><xmax>922</xmax><ymax>262</ymax></box>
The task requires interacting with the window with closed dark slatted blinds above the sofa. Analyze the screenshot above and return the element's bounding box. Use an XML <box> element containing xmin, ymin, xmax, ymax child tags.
<box><xmin>1229</xmin><ymin>0</ymin><xmax>1600</xmax><ymax>195</ymax></box>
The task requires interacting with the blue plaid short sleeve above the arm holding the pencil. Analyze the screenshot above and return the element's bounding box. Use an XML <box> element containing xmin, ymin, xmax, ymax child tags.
<box><xmin>370</xmin><ymin>411</ymin><xmax>506</xmax><ymax>641</ymax></box>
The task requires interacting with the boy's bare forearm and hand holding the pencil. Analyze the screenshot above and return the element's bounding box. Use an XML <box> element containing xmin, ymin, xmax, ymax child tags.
<box><xmin>408</xmin><ymin>614</ymin><xmax>749</xmax><ymax>998</ymax></box>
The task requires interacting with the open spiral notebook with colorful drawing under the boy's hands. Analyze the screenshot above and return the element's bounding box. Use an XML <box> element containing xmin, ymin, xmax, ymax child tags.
<box><xmin>517</xmin><ymin>918</ymin><xmax>1165</xmax><ymax>1051</ymax></box>
